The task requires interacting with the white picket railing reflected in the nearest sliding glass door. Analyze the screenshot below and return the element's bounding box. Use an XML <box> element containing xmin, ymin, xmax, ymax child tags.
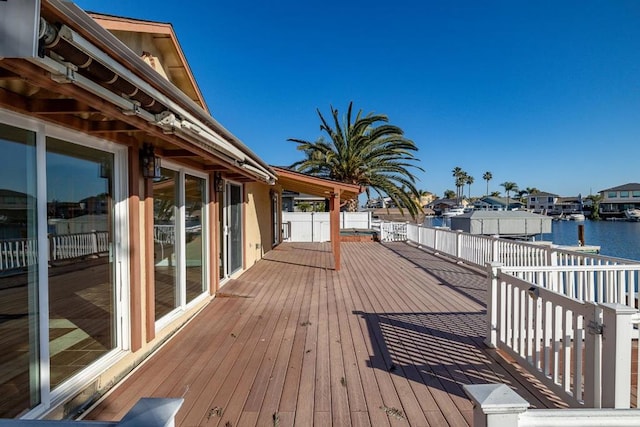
<box><xmin>0</xmin><ymin>231</ymin><xmax>109</xmax><ymax>273</ymax></box>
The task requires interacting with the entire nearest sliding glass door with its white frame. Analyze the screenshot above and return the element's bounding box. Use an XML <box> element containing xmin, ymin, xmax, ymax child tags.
<box><xmin>0</xmin><ymin>113</ymin><xmax>128</xmax><ymax>418</ymax></box>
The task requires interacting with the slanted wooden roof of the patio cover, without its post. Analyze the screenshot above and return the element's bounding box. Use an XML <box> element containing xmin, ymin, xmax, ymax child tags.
<box><xmin>271</xmin><ymin>166</ymin><xmax>364</xmax><ymax>200</ymax></box>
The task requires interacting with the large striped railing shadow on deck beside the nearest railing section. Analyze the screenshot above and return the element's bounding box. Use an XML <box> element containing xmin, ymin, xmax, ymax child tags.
<box><xmin>354</xmin><ymin>311</ymin><xmax>565</xmax><ymax>407</ymax></box>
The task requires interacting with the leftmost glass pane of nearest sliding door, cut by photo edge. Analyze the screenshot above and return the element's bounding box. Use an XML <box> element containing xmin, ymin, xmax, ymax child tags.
<box><xmin>0</xmin><ymin>124</ymin><xmax>40</xmax><ymax>418</ymax></box>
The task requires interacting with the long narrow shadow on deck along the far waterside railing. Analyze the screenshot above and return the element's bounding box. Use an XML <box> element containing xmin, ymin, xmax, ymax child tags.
<box><xmin>384</xmin><ymin>243</ymin><xmax>487</xmax><ymax>307</ymax></box>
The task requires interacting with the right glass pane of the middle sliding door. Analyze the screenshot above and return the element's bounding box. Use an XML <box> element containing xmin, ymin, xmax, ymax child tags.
<box><xmin>185</xmin><ymin>175</ymin><xmax>207</xmax><ymax>303</ymax></box>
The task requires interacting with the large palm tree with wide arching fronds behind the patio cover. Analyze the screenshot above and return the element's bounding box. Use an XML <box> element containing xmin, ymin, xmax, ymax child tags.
<box><xmin>289</xmin><ymin>102</ymin><xmax>423</xmax><ymax>217</ymax></box>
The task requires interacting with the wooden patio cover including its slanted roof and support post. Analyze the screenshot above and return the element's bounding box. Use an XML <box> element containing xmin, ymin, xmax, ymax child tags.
<box><xmin>271</xmin><ymin>166</ymin><xmax>364</xmax><ymax>270</ymax></box>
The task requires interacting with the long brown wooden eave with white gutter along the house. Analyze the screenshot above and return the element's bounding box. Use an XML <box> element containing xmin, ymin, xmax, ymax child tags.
<box><xmin>0</xmin><ymin>0</ymin><xmax>275</xmax><ymax>184</ymax></box>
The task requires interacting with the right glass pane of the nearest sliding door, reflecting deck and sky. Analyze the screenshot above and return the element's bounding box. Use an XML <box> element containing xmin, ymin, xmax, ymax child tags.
<box><xmin>46</xmin><ymin>138</ymin><xmax>117</xmax><ymax>388</ymax></box>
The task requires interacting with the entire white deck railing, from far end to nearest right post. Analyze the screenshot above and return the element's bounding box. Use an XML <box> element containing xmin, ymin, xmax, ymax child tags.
<box><xmin>381</xmin><ymin>223</ymin><xmax>640</xmax><ymax>408</ymax></box>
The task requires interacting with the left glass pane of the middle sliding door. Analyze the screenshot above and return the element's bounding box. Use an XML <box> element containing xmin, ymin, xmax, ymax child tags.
<box><xmin>153</xmin><ymin>168</ymin><xmax>179</xmax><ymax>320</ymax></box>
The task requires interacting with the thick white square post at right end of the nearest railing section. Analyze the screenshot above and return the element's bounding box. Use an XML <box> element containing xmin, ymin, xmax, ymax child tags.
<box><xmin>600</xmin><ymin>303</ymin><xmax>638</xmax><ymax>409</ymax></box>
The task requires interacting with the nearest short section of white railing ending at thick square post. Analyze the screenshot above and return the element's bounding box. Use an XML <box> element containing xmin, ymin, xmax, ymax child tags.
<box><xmin>487</xmin><ymin>264</ymin><xmax>640</xmax><ymax>408</ymax></box>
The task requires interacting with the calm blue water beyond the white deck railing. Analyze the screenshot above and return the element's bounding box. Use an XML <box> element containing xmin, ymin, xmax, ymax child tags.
<box><xmin>424</xmin><ymin>218</ymin><xmax>640</xmax><ymax>261</ymax></box>
